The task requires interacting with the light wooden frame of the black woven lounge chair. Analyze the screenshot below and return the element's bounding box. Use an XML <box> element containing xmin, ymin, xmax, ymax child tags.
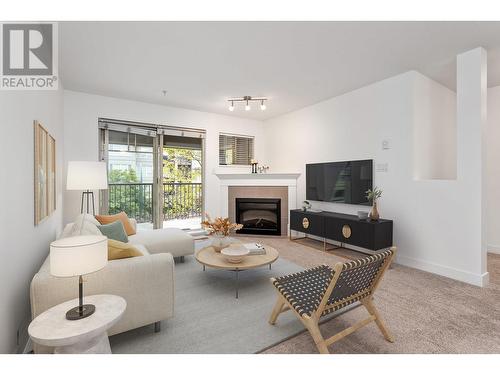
<box><xmin>269</xmin><ymin>247</ymin><xmax>396</xmax><ymax>354</ymax></box>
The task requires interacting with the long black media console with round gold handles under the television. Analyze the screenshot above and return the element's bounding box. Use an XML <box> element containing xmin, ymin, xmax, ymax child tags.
<box><xmin>290</xmin><ymin>210</ymin><xmax>392</xmax><ymax>251</ymax></box>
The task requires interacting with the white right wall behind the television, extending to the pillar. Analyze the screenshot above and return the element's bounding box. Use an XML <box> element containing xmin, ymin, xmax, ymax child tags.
<box><xmin>265</xmin><ymin>72</ymin><xmax>485</xmax><ymax>285</ymax></box>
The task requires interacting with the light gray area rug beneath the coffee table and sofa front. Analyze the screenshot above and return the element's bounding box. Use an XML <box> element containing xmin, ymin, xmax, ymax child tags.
<box><xmin>110</xmin><ymin>256</ymin><xmax>304</xmax><ymax>354</ymax></box>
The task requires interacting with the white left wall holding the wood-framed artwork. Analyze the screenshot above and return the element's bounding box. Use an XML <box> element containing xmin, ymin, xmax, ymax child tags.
<box><xmin>0</xmin><ymin>91</ymin><xmax>63</xmax><ymax>353</ymax></box>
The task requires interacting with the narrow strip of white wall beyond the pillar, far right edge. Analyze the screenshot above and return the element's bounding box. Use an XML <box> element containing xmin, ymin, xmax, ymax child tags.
<box><xmin>487</xmin><ymin>86</ymin><xmax>500</xmax><ymax>254</ymax></box>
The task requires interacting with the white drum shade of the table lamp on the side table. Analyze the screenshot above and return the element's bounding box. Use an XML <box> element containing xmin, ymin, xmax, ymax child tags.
<box><xmin>50</xmin><ymin>236</ymin><xmax>108</xmax><ymax>277</ymax></box>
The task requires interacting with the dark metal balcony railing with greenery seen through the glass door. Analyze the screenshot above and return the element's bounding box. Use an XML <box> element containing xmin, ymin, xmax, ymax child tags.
<box><xmin>108</xmin><ymin>182</ymin><xmax>203</xmax><ymax>223</ymax></box>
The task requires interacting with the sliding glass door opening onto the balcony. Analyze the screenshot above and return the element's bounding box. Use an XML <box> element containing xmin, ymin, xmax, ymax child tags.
<box><xmin>99</xmin><ymin>119</ymin><xmax>204</xmax><ymax>229</ymax></box>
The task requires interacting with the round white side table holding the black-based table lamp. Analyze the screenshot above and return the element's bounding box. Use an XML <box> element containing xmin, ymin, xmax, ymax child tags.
<box><xmin>28</xmin><ymin>294</ymin><xmax>127</xmax><ymax>354</ymax></box>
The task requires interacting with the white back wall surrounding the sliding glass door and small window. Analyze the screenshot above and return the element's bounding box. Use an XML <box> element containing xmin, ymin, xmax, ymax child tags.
<box><xmin>64</xmin><ymin>90</ymin><xmax>264</xmax><ymax>222</ymax></box>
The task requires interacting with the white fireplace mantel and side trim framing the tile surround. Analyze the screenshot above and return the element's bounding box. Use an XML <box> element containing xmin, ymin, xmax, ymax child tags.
<box><xmin>215</xmin><ymin>173</ymin><xmax>300</xmax><ymax>217</ymax></box>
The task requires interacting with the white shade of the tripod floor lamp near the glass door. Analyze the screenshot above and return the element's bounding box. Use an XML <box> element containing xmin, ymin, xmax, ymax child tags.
<box><xmin>66</xmin><ymin>161</ymin><xmax>108</xmax><ymax>190</ymax></box>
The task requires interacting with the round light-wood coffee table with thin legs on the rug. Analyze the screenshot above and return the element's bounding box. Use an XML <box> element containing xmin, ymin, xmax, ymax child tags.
<box><xmin>195</xmin><ymin>243</ymin><xmax>279</xmax><ymax>298</ymax></box>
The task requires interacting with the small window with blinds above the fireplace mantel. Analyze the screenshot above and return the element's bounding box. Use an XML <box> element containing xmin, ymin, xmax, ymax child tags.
<box><xmin>219</xmin><ymin>134</ymin><xmax>254</xmax><ymax>165</ymax></box>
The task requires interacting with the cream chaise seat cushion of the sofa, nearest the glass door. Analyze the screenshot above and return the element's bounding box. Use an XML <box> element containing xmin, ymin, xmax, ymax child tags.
<box><xmin>128</xmin><ymin>228</ymin><xmax>194</xmax><ymax>257</ymax></box>
